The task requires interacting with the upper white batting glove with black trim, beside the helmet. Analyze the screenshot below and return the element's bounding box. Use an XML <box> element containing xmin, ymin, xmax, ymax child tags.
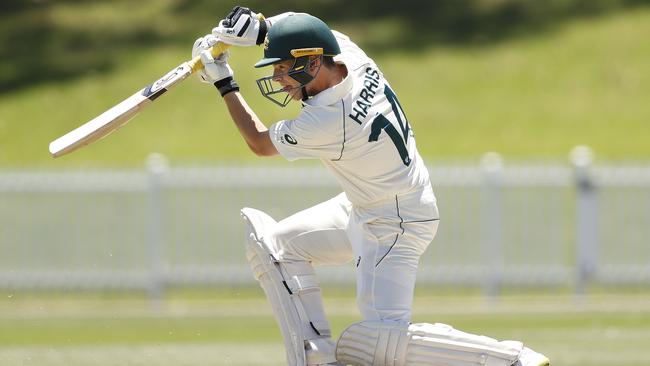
<box><xmin>212</xmin><ymin>6</ymin><xmax>268</xmax><ymax>46</ymax></box>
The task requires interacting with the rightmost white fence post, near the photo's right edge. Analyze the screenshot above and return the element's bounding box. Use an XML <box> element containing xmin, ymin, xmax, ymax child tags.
<box><xmin>569</xmin><ymin>146</ymin><xmax>598</xmax><ymax>296</ymax></box>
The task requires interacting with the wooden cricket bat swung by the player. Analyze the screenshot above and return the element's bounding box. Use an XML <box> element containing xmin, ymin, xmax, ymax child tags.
<box><xmin>50</xmin><ymin>42</ymin><xmax>229</xmax><ymax>158</ymax></box>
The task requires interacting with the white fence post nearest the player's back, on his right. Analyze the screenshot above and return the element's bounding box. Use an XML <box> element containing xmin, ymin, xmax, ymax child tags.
<box><xmin>480</xmin><ymin>152</ymin><xmax>504</xmax><ymax>302</ymax></box>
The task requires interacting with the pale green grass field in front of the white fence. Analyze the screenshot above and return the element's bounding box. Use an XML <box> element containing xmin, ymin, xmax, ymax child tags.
<box><xmin>0</xmin><ymin>289</ymin><xmax>650</xmax><ymax>366</ymax></box>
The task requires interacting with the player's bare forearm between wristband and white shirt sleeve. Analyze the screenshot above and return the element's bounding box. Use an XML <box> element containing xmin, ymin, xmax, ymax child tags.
<box><xmin>223</xmin><ymin>92</ymin><xmax>278</xmax><ymax>156</ymax></box>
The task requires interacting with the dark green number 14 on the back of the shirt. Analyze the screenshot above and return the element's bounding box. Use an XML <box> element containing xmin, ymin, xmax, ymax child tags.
<box><xmin>368</xmin><ymin>85</ymin><xmax>411</xmax><ymax>166</ymax></box>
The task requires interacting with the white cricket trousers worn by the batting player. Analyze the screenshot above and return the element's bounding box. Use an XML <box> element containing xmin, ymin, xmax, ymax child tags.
<box><xmin>272</xmin><ymin>186</ymin><xmax>439</xmax><ymax>323</ymax></box>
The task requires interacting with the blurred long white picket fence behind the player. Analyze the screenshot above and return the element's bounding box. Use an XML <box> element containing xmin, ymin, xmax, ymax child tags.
<box><xmin>0</xmin><ymin>152</ymin><xmax>650</xmax><ymax>296</ymax></box>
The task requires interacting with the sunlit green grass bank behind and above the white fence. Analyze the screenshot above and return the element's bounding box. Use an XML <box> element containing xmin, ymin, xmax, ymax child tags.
<box><xmin>0</xmin><ymin>7</ymin><xmax>650</xmax><ymax>168</ymax></box>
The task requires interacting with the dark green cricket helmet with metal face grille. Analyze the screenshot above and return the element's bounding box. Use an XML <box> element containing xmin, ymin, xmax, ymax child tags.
<box><xmin>255</xmin><ymin>13</ymin><xmax>341</xmax><ymax>107</ymax></box>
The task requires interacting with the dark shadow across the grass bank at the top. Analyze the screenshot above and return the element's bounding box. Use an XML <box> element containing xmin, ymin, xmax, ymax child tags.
<box><xmin>0</xmin><ymin>0</ymin><xmax>650</xmax><ymax>95</ymax></box>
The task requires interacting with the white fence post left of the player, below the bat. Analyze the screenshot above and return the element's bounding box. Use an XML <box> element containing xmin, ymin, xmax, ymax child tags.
<box><xmin>147</xmin><ymin>153</ymin><xmax>169</xmax><ymax>310</ymax></box>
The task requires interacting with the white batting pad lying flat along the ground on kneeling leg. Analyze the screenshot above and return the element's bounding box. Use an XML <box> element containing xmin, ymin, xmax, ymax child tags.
<box><xmin>336</xmin><ymin>322</ymin><xmax>523</xmax><ymax>366</ymax></box>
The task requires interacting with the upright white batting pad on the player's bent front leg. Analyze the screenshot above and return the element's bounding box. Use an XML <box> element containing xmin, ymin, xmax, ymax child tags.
<box><xmin>241</xmin><ymin>208</ymin><xmax>336</xmax><ymax>366</ymax></box>
